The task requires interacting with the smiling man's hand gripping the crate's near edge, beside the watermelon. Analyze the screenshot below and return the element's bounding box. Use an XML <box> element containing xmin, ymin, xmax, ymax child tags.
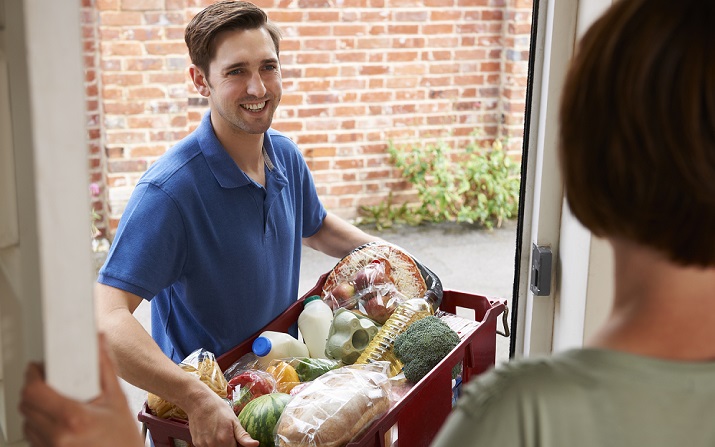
<box><xmin>184</xmin><ymin>389</ymin><xmax>258</xmax><ymax>447</ymax></box>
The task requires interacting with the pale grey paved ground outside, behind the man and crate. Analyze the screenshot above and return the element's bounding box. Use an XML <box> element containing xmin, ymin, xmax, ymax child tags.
<box><xmin>123</xmin><ymin>221</ymin><xmax>516</xmax><ymax>440</ymax></box>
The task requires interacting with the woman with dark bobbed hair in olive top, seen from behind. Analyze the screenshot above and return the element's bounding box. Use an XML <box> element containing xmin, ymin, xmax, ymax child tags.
<box><xmin>434</xmin><ymin>0</ymin><xmax>715</xmax><ymax>447</ymax></box>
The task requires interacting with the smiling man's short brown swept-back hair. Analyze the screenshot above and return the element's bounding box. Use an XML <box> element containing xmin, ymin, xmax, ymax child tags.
<box><xmin>184</xmin><ymin>0</ymin><xmax>281</xmax><ymax>76</ymax></box>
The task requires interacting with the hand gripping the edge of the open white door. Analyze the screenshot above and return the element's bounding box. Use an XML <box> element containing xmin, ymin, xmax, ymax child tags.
<box><xmin>20</xmin><ymin>336</ymin><xmax>144</xmax><ymax>447</ymax></box>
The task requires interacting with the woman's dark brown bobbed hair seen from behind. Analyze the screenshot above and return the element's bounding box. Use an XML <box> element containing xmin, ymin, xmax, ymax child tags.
<box><xmin>559</xmin><ymin>0</ymin><xmax>715</xmax><ymax>266</ymax></box>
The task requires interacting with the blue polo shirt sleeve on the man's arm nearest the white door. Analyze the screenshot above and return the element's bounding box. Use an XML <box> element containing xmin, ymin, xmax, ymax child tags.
<box><xmin>97</xmin><ymin>183</ymin><xmax>186</xmax><ymax>299</ymax></box>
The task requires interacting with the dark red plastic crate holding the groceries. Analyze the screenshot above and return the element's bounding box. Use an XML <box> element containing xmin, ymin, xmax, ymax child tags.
<box><xmin>138</xmin><ymin>274</ymin><xmax>506</xmax><ymax>447</ymax></box>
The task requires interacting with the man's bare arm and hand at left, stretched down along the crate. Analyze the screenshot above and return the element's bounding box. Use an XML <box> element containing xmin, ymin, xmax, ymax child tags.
<box><xmin>95</xmin><ymin>284</ymin><xmax>258</xmax><ymax>447</ymax></box>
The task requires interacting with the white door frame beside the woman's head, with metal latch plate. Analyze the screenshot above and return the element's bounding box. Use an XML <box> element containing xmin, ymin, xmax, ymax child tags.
<box><xmin>513</xmin><ymin>0</ymin><xmax>613</xmax><ymax>356</ymax></box>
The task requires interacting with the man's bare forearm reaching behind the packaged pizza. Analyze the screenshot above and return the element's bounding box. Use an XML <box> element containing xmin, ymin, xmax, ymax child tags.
<box><xmin>303</xmin><ymin>213</ymin><xmax>382</xmax><ymax>258</ymax></box>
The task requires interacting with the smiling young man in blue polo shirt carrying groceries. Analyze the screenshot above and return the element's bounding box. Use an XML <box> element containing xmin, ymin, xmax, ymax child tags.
<box><xmin>91</xmin><ymin>1</ymin><xmax>376</xmax><ymax>447</ymax></box>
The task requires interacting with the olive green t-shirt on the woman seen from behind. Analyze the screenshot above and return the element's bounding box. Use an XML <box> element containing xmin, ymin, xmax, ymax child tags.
<box><xmin>432</xmin><ymin>349</ymin><xmax>715</xmax><ymax>447</ymax></box>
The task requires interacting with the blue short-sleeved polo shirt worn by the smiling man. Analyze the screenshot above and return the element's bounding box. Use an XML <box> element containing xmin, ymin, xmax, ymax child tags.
<box><xmin>98</xmin><ymin>113</ymin><xmax>326</xmax><ymax>362</ymax></box>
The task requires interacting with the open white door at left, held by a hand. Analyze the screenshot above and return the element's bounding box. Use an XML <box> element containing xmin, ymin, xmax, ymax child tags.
<box><xmin>0</xmin><ymin>0</ymin><xmax>99</xmax><ymax>446</ymax></box>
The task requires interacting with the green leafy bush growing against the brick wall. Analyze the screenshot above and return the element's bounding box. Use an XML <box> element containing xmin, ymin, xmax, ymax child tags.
<box><xmin>361</xmin><ymin>138</ymin><xmax>520</xmax><ymax>229</ymax></box>
